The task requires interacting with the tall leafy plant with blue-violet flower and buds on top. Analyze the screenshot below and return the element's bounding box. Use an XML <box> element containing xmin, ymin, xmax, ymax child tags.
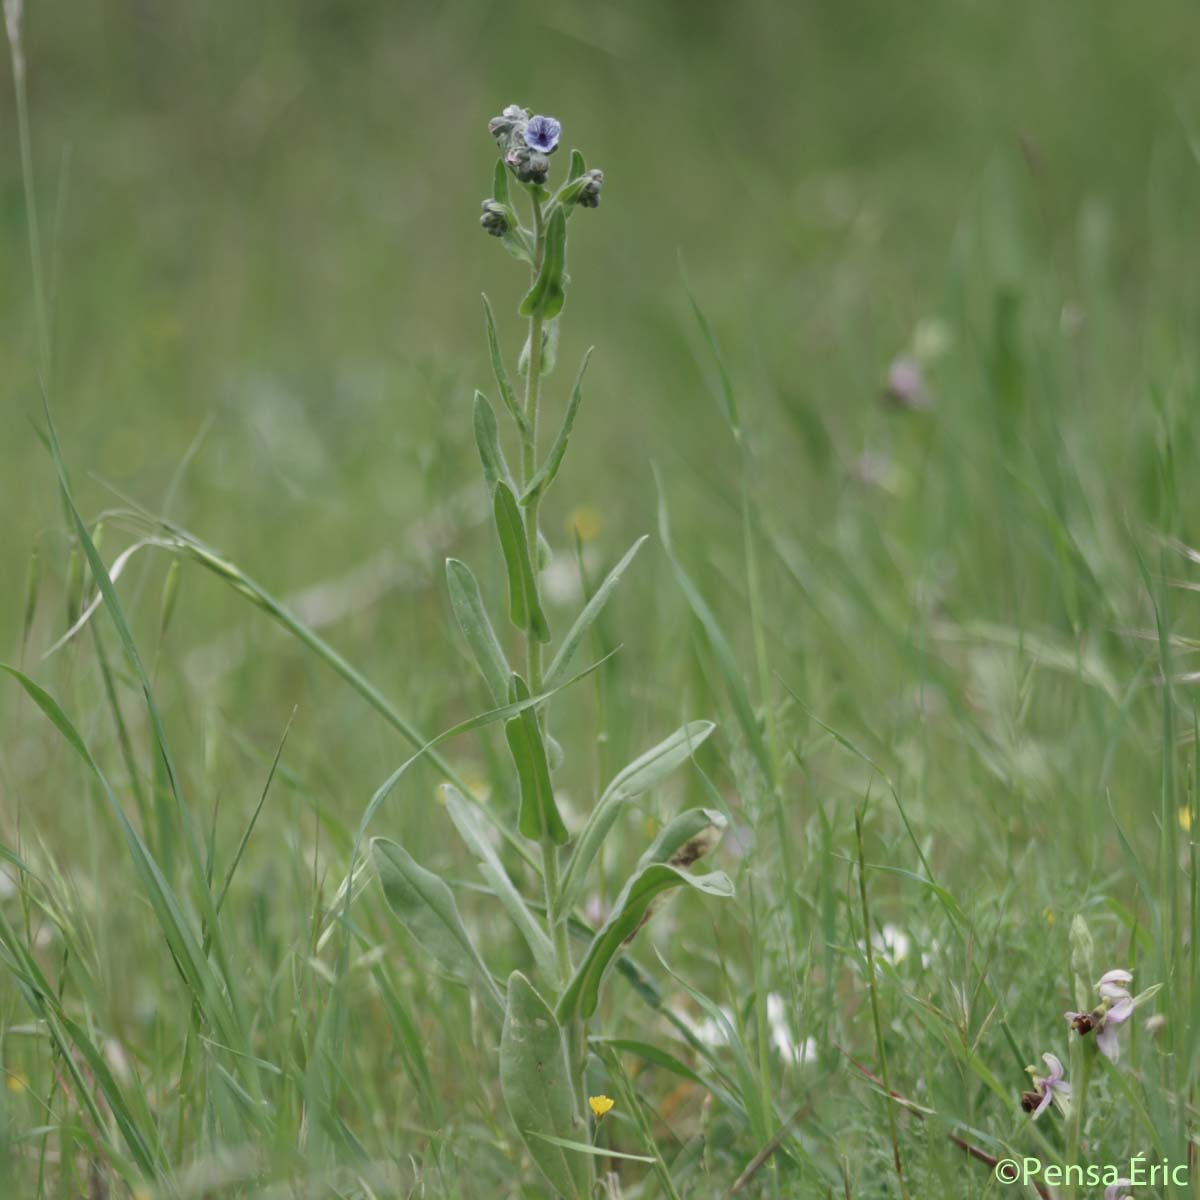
<box><xmin>372</xmin><ymin>104</ymin><xmax>733</xmax><ymax>1198</ymax></box>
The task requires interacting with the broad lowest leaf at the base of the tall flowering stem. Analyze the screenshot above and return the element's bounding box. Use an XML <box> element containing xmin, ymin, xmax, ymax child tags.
<box><xmin>500</xmin><ymin>971</ymin><xmax>590</xmax><ymax>1200</ymax></box>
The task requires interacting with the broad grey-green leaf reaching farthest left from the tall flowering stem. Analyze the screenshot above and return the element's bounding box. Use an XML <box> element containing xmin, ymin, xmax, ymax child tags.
<box><xmin>371</xmin><ymin>838</ymin><xmax>504</xmax><ymax>1012</ymax></box>
